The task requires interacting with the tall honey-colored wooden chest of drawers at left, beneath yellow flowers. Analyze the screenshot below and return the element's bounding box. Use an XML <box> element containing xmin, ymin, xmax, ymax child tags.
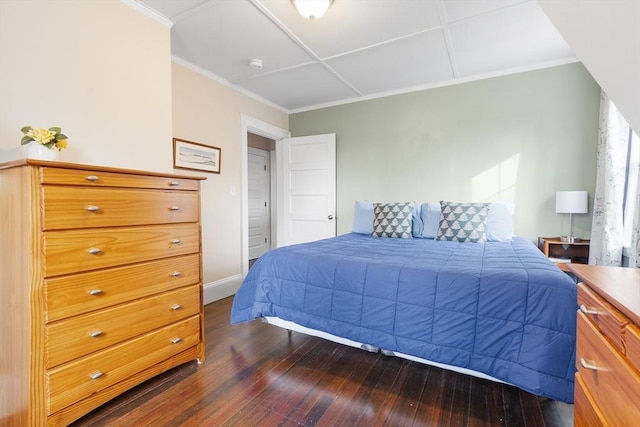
<box><xmin>0</xmin><ymin>160</ymin><xmax>204</xmax><ymax>426</ymax></box>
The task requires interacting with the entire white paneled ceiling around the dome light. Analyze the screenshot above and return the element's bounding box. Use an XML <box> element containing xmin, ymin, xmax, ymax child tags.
<box><xmin>132</xmin><ymin>0</ymin><xmax>575</xmax><ymax>110</ymax></box>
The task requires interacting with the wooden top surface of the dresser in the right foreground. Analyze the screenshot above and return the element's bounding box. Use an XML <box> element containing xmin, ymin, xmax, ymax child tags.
<box><xmin>569</xmin><ymin>264</ymin><xmax>640</xmax><ymax>325</ymax></box>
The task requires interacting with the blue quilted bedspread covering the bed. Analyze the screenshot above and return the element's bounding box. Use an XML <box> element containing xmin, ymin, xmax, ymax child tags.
<box><xmin>231</xmin><ymin>233</ymin><xmax>578</xmax><ymax>403</ymax></box>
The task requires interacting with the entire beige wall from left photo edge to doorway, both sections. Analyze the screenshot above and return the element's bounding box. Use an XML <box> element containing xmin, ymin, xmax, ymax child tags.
<box><xmin>0</xmin><ymin>0</ymin><xmax>288</xmax><ymax>304</ymax></box>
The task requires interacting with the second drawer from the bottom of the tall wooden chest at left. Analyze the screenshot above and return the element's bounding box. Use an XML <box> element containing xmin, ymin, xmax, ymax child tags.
<box><xmin>45</xmin><ymin>285</ymin><xmax>200</xmax><ymax>368</ymax></box>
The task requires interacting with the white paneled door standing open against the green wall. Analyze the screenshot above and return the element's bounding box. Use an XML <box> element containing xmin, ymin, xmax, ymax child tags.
<box><xmin>276</xmin><ymin>133</ymin><xmax>336</xmax><ymax>247</ymax></box>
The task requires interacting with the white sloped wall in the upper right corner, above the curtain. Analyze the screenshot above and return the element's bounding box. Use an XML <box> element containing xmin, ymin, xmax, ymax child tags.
<box><xmin>538</xmin><ymin>0</ymin><xmax>640</xmax><ymax>133</ymax></box>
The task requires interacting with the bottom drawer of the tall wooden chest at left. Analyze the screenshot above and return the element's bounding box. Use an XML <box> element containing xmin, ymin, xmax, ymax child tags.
<box><xmin>45</xmin><ymin>316</ymin><xmax>200</xmax><ymax>415</ymax></box>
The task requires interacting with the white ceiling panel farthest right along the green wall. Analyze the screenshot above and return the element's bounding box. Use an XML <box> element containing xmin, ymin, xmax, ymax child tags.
<box><xmin>449</xmin><ymin>2</ymin><xmax>573</xmax><ymax>77</ymax></box>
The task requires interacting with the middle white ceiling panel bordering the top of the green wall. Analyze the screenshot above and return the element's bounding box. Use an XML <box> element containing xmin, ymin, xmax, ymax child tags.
<box><xmin>326</xmin><ymin>29</ymin><xmax>454</xmax><ymax>95</ymax></box>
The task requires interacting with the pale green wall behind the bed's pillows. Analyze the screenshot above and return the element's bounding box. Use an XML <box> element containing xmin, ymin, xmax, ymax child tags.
<box><xmin>289</xmin><ymin>63</ymin><xmax>600</xmax><ymax>244</ymax></box>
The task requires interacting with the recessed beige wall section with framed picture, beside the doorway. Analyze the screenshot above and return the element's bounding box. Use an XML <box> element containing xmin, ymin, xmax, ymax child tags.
<box><xmin>173</xmin><ymin>63</ymin><xmax>288</xmax><ymax>296</ymax></box>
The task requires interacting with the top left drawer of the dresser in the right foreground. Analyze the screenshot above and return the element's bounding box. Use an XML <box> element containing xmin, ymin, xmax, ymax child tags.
<box><xmin>578</xmin><ymin>283</ymin><xmax>629</xmax><ymax>354</ymax></box>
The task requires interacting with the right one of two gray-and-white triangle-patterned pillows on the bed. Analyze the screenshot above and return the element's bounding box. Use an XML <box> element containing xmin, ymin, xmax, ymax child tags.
<box><xmin>436</xmin><ymin>202</ymin><xmax>489</xmax><ymax>243</ymax></box>
